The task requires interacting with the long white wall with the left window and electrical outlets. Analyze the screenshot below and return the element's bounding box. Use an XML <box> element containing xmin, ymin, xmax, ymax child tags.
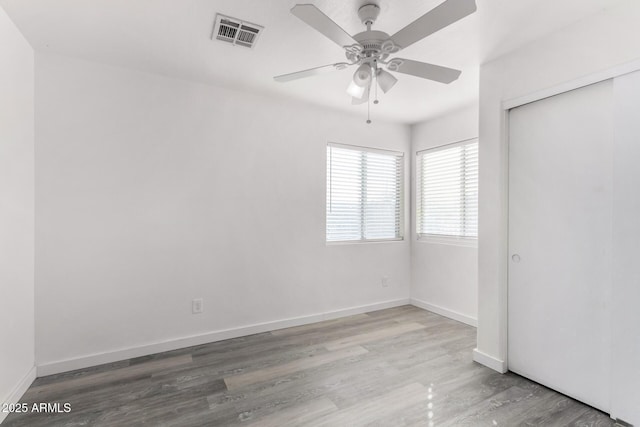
<box><xmin>36</xmin><ymin>53</ymin><xmax>410</xmax><ymax>373</ymax></box>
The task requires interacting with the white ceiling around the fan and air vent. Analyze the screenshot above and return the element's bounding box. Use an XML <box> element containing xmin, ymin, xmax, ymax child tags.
<box><xmin>0</xmin><ymin>0</ymin><xmax>623</xmax><ymax>123</ymax></box>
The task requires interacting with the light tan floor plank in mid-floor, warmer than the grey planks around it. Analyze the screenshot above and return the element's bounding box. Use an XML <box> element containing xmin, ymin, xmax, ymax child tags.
<box><xmin>224</xmin><ymin>346</ymin><xmax>368</xmax><ymax>390</ymax></box>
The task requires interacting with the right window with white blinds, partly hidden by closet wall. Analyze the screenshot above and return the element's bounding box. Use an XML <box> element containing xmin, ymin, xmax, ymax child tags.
<box><xmin>416</xmin><ymin>139</ymin><xmax>478</xmax><ymax>239</ymax></box>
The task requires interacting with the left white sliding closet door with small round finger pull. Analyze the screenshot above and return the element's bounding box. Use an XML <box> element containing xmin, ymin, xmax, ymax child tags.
<box><xmin>508</xmin><ymin>81</ymin><xmax>613</xmax><ymax>412</ymax></box>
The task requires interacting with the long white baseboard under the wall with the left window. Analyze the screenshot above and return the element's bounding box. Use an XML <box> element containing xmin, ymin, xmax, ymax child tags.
<box><xmin>38</xmin><ymin>298</ymin><xmax>410</xmax><ymax>377</ymax></box>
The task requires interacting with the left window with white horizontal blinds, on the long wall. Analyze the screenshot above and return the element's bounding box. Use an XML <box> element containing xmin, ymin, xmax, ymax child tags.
<box><xmin>327</xmin><ymin>143</ymin><xmax>404</xmax><ymax>242</ymax></box>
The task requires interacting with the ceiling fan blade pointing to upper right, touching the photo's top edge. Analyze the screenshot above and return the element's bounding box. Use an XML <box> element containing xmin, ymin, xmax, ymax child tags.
<box><xmin>391</xmin><ymin>0</ymin><xmax>477</xmax><ymax>49</ymax></box>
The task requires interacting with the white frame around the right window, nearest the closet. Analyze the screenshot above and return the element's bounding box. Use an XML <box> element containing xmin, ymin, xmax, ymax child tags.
<box><xmin>414</xmin><ymin>137</ymin><xmax>480</xmax><ymax>248</ymax></box>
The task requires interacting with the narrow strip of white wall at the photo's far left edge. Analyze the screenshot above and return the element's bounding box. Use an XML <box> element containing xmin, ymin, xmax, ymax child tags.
<box><xmin>0</xmin><ymin>4</ymin><xmax>35</xmax><ymax>421</ymax></box>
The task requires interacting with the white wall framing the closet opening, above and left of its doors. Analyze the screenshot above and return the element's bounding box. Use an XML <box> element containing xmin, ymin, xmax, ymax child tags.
<box><xmin>476</xmin><ymin>0</ymin><xmax>640</xmax><ymax>370</ymax></box>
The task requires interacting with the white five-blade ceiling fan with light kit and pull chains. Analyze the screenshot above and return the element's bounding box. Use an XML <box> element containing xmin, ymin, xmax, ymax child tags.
<box><xmin>274</xmin><ymin>0</ymin><xmax>476</xmax><ymax>123</ymax></box>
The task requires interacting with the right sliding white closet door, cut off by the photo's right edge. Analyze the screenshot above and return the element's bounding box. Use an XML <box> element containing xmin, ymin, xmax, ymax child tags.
<box><xmin>611</xmin><ymin>71</ymin><xmax>640</xmax><ymax>426</ymax></box>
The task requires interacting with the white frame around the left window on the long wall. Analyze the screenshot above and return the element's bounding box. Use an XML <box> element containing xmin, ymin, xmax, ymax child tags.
<box><xmin>324</xmin><ymin>141</ymin><xmax>407</xmax><ymax>246</ymax></box>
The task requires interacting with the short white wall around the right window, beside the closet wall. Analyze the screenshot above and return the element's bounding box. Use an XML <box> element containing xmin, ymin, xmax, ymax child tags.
<box><xmin>411</xmin><ymin>104</ymin><xmax>478</xmax><ymax>324</ymax></box>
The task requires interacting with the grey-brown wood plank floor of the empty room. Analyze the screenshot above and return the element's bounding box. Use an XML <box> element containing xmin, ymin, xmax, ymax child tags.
<box><xmin>3</xmin><ymin>306</ymin><xmax>613</xmax><ymax>427</ymax></box>
